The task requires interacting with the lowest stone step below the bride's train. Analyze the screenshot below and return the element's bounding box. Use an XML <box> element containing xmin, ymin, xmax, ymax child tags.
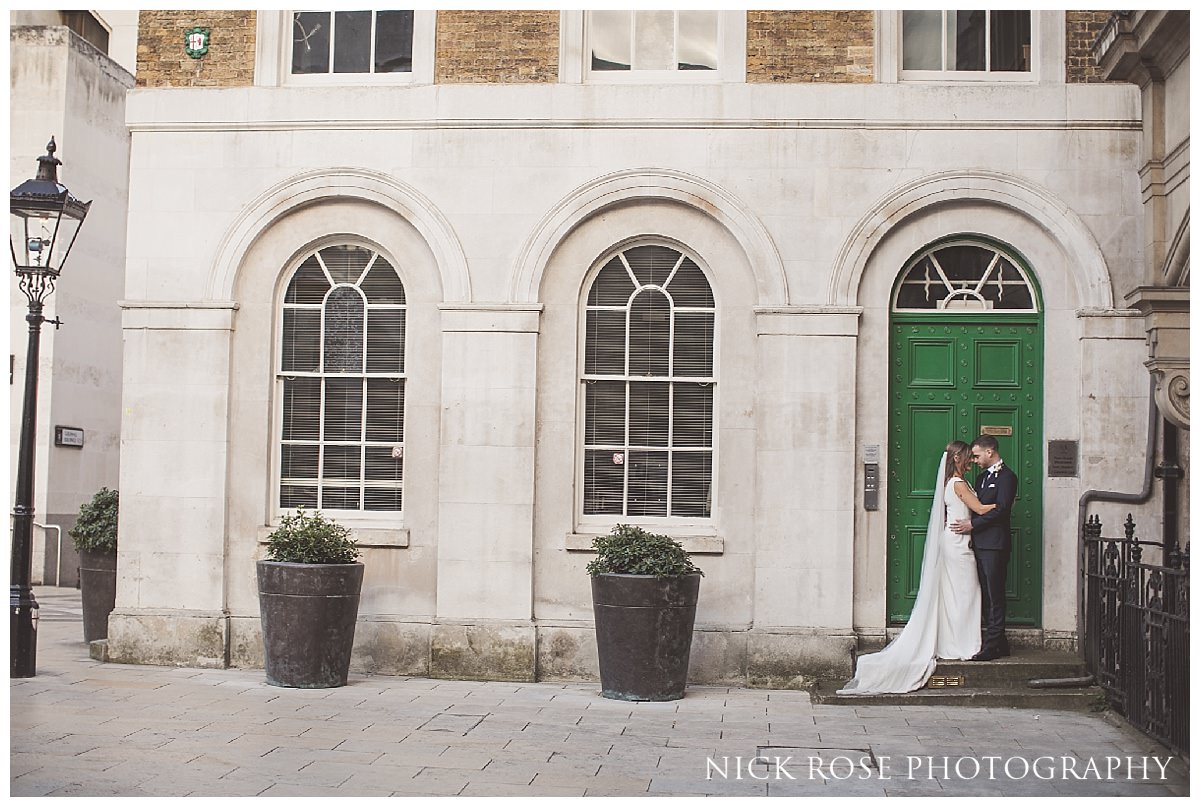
<box><xmin>810</xmin><ymin>681</ymin><xmax>1104</xmax><ymax>711</ymax></box>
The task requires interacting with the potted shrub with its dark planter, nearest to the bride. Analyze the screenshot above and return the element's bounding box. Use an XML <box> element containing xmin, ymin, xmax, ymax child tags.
<box><xmin>587</xmin><ymin>524</ymin><xmax>704</xmax><ymax>700</ymax></box>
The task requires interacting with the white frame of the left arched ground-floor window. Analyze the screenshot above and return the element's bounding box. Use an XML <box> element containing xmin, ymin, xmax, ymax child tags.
<box><xmin>270</xmin><ymin>235</ymin><xmax>409</xmax><ymax>525</ymax></box>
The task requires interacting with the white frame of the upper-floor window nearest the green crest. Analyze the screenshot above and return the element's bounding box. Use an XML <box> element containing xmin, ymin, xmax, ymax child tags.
<box><xmin>254</xmin><ymin>8</ymin><xmax>437</xmax><ymax>86</ymax></box>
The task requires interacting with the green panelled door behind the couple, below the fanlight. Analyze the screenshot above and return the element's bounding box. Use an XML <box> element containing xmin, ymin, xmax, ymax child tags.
<box><xmin>887</xmin><ymin>312</ymin><xmax>1043</xmax><ymax>626</ymax></box>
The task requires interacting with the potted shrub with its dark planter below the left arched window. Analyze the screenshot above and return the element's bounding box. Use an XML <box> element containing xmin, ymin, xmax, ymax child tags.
<box><xmin>258</xmin><ymin>508</ymin><xmax>362</xmax><ymax>689</ymax></box>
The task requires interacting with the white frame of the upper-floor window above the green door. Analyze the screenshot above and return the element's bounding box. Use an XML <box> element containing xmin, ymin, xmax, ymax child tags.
<box><xmin>875</xmin><ymin>10</ymin><xmax>1067</xmax><ymax>84</ymax></box>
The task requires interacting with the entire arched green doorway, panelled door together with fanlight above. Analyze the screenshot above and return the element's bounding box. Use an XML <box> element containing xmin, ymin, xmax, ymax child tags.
<box><xmin>887</xmin><ymin>235</ymin><xmax>1043</xmax><ymax>627</ymax></box>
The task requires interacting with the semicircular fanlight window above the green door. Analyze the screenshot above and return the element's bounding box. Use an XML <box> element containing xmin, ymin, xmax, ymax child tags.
<box><xmin>893</xmin><ymin>239</ymin><xmax>1037</xmax><ymax>313</ymax></box>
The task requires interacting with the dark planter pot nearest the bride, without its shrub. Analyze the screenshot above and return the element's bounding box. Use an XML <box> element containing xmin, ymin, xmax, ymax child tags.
<box><xmin>592</xmin><ymin>574</ymin><xmax>700</xmax><ymax>700</ymax></box>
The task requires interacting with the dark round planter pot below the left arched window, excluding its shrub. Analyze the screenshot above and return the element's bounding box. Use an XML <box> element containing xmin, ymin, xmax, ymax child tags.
<box><xmin>258</xmin><ymin>561</ymin><xmax>362</xmax><ymax>689</ymax></box>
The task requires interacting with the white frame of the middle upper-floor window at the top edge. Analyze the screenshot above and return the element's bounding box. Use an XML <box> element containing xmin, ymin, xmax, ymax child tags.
<box><xmin>558</xmin><ymin>10</ymin><xmax>746</xmax><ymax>84</ymax></box>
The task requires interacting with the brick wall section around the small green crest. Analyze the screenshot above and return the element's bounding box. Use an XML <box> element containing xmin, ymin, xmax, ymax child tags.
<box><xmin>137</xmin><ymin>11</ymin><xmax>256</xmax><ymax>86</ymax></box>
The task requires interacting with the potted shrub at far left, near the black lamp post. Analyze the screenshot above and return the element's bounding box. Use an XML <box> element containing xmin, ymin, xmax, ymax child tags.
<box><xmin>67</xmin><ymin>488</ymin><xmax>118</xmax><ymax>641</ymax></box>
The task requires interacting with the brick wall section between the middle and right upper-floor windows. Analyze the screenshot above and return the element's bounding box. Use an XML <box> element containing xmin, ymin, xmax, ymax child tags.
<box><xmin>746</xmin><ymin>11</ymin><xmax>875</xmax><ymax>83</ymax></box>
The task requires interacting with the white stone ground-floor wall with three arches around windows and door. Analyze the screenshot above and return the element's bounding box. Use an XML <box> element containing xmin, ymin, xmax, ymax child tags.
<box><xmin>114</xmin><ymin>72</ymin><xmax>1145</xmax><ymax>681</ymax></box>
